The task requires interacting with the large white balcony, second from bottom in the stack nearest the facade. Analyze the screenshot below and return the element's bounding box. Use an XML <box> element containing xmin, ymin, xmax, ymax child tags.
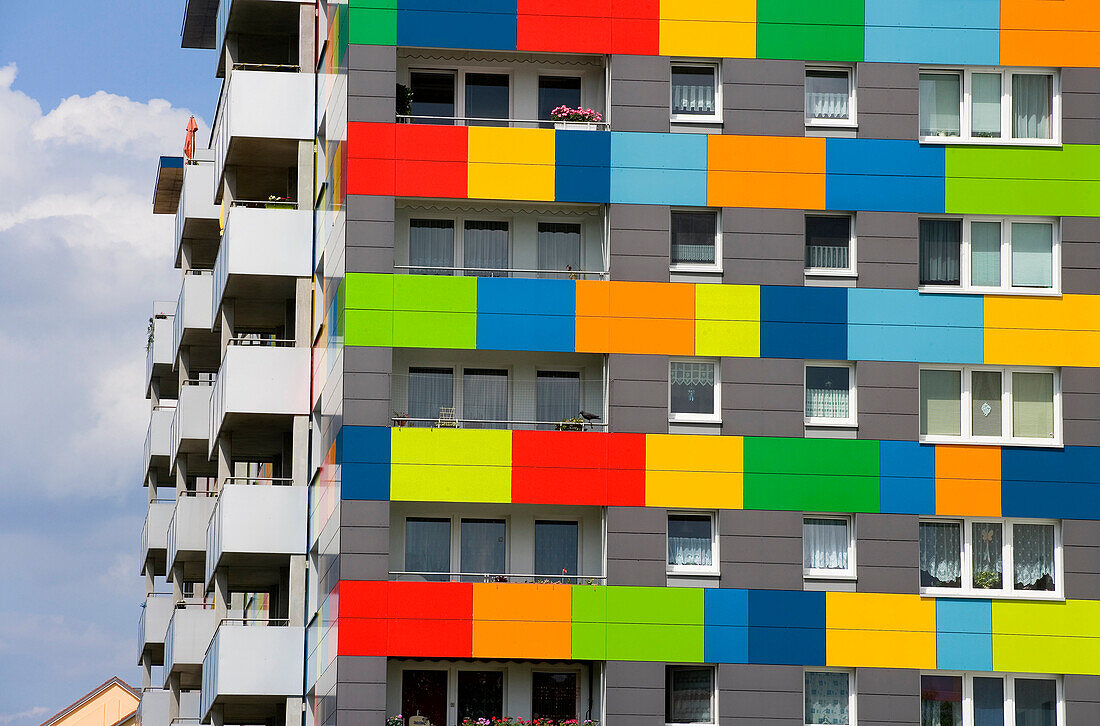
<box><xmin>206</xmin><ymin>477</ymin><xmax>308</xmax><ymax>586</ymax></box>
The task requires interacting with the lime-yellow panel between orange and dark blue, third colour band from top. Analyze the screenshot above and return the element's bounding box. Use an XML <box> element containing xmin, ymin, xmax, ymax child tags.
<box><xmin>695</xmin><ymin>285</ymin><xmax>760</xmax><ymax>358</ymax></box>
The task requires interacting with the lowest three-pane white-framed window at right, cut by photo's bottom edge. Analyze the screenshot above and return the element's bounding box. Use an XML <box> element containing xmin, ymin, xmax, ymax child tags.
<box><xmin>921</xmin><ymin>673</ymin><xmax>1065</xmax><ymax>726</ymax></box>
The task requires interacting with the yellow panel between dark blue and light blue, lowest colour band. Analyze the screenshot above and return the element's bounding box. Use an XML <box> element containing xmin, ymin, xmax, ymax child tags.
<box><xmin>825</xmin><ymin>593</ymin><xmax>936</xmax><ymax>669</ymax></box>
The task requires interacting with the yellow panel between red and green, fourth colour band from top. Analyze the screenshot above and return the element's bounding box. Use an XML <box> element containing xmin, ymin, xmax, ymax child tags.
<box><xmin>646</xmin><ymin>433</ymin><xmax>745</xmax><ymax>509</ymax></box>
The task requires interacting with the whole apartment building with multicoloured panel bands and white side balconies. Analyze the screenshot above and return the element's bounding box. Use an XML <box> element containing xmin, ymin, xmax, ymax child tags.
<box><xmin>139</xmin><ymin>0</ymin><xmax>1100</xmax><ymax>726</ymax></box>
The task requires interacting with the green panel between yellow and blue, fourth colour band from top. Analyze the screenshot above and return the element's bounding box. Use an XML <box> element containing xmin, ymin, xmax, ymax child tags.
<box><xmin>745</xmin><ymin>437</ymin><xmax>879</xmax><ymax>513</ymax></box>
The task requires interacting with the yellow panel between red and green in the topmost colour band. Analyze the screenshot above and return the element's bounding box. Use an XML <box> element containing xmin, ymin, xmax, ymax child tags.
<box><xmin>660</xmin><ymin>0</ymin><xmax>757</xmax><ymax>58</ymax></box>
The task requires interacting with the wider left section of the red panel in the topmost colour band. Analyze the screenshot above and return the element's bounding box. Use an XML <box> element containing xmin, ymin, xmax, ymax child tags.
<box><xmin>516</xmin><ymin>0</ymin><xmax>612</xmax><ymax>53</ymax></box>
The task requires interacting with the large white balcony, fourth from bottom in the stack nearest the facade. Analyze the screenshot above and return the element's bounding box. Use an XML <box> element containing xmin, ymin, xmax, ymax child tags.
<box><xmin>212</xmin><ymin>201</ymin><xmax>314</xmax><ymax>310</ymax></box>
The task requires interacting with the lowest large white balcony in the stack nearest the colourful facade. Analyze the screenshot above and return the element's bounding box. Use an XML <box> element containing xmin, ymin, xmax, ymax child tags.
<box><xmin>199</xmin><ymin>624</ymin><xmax>306</xmax><ymax>723</ymax></box>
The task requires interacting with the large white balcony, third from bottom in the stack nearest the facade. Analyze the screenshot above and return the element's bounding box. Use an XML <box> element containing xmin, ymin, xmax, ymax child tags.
<box><xmin>209</xmin><ymin>338</ymin><xmax>310</xmax><ymax>455</ymax></box>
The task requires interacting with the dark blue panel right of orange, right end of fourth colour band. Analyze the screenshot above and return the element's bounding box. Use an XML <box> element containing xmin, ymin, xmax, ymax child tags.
<box><xmin>1001</xmin><ymin>447</ymin><xmax>1100</xmax><ymax>519</ymax></box>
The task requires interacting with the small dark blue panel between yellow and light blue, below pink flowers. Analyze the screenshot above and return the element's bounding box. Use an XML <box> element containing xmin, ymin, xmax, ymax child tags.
<box><xmin>554</xmin><ymin>131</ymin><xmax>612</xmax><ymax>202</ymax></box>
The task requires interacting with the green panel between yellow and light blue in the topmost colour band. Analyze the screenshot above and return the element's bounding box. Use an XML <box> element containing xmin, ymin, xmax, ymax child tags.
<box><xmin>757</xmin><ymin>0</ymin><xmax>864</xmax><ymax>61</ymax></box>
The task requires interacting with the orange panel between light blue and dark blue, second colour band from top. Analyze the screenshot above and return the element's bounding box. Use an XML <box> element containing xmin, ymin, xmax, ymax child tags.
<box><xmin>706</xmin><ymin>134</ymin><xmax>825</xmax><ymax>209</ymax></box>
